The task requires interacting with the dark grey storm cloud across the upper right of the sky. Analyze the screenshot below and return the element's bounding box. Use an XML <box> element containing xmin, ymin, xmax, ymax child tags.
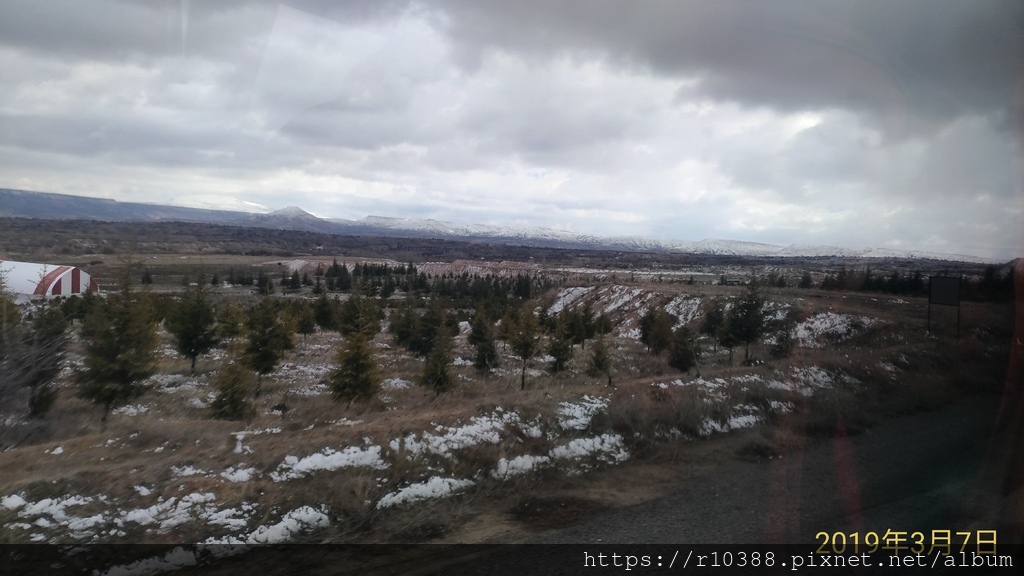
<box><xmin>434</xmin><ymin>0</ymin><xmax>1024</xmax><ymax>131</ymax></box>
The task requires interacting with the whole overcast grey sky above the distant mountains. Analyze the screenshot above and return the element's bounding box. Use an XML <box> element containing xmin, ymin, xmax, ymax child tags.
<box><xmin>0</xmin><ymin>0</ymin><xmax>1024</xmax><ymax>258</ymax></box>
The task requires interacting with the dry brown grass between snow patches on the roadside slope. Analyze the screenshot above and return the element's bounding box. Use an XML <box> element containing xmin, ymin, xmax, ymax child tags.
<box><xmin>0</xmin><ymin>270</ymin><xmax>1010</xmax><ymax>542</ymax></box>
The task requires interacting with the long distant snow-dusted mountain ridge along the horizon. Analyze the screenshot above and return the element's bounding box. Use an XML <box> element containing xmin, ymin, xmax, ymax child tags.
<box><xmin>0</xmin><ymin>189</ymin><xmax>991</xmax><ymax>263</ymax></box>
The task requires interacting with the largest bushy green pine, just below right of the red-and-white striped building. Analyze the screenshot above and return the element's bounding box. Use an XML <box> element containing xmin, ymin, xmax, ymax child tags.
<box><xmin>77</xmin><ymin>273</ymin><xmax>157</xmax><ymax>423</ymax></box>
